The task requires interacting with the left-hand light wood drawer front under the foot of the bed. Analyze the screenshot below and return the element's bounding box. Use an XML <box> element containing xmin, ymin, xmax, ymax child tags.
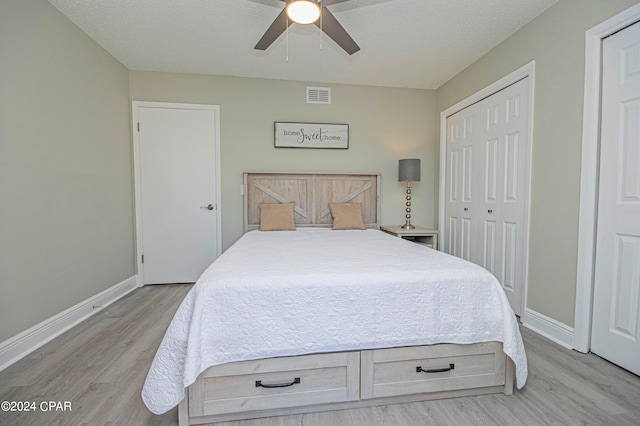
<box><xmin>189</xmin><ymin>352</ymin><xmax>360</xmax><ymax>416</ymax></box>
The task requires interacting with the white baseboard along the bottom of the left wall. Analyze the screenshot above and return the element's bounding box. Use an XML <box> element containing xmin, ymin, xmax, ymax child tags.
<box><xmin>0</xmin><ymin>276</ymin><xmax>138</xmax><ymax>371</ymax></box>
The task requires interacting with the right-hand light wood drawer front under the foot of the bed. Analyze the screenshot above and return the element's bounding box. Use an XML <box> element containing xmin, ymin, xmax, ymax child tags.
<box><xmin>360</xmin><ymin>342</ymin><xmax>506</xmax><ymax>399</ymax></box>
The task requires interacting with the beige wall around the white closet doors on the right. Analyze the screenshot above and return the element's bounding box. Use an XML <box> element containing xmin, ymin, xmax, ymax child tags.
<box><xmin>437</xmin><ymin>0</ymin><xmax>637</xmax><ymax>326</ymax></box>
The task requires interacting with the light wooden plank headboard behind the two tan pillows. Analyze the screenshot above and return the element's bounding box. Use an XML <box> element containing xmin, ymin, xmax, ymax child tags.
<box><xmin>244</xmin><ymin>172</ymin><xmax>380</xmax><ymax>232</ymax></box>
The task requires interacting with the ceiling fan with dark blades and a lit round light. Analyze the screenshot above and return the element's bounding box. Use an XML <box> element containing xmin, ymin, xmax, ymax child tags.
<box><xmin>254</xmin><ymin>0</ymin><xmax>360</xmax><ymax>55</ymax></box>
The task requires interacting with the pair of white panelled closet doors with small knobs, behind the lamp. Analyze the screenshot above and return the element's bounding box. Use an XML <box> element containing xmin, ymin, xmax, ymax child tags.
<box><xmin>445</xmin><ymin>78</ymin><xmax>530</xmax><ymax>315</ymax></box>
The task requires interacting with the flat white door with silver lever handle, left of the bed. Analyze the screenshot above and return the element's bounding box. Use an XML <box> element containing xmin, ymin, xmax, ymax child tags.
<box><xmin>134</xmin><ymin>103</ymin><xmax>219</xmax><ymax>284</ymax></box>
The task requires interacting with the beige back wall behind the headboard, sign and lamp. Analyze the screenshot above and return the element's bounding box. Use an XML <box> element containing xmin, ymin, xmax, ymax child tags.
<box><xmin>130</xmin><ymin>71</ymin><xmax>437</xmax><ymax>248</ymax></box>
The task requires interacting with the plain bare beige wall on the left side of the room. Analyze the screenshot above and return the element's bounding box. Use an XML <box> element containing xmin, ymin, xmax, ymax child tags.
<box><xmin>0</xmin><ymin>0</ymin><xmax>135</xmax><ymax>342</ymax></box>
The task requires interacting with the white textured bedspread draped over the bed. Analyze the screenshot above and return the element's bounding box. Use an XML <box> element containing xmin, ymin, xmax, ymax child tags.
<box><xmin>142</xmin><ymin>229</ymin><xmax>527</xmax><ymax>414</ymax></box>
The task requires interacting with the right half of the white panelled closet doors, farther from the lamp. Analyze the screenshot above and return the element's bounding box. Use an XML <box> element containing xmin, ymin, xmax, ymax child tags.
<box><xmin>475</xmin><ymin>78</ymin><xmax>529</xmax><ymax>315</ymax></box>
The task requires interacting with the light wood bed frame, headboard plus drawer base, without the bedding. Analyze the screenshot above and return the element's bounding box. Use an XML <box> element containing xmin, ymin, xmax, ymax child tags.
<box><xmin>178</xmin><ymin>173</ymin><xmax>514</xmax><ymax>426</ymax></box>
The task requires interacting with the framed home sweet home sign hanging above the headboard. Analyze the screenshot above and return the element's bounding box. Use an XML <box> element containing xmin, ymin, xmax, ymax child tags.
<box><xmin>275</xmin><ymin>122</ymin><xmax>349</xmax><ymax>149</ymax></box>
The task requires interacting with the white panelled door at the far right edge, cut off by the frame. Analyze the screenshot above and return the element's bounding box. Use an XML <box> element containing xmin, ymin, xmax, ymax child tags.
<box><xmin>591</xmin><ymin>19</ymin><xmax>640</xmax><ymax>375</ymax></box>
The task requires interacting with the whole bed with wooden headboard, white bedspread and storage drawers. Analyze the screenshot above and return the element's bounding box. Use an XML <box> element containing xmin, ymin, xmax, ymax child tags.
<box><xmin>142</xmin><ymin>173</ymin><xmax>527</xmax><ymax>425</ymax></box>
